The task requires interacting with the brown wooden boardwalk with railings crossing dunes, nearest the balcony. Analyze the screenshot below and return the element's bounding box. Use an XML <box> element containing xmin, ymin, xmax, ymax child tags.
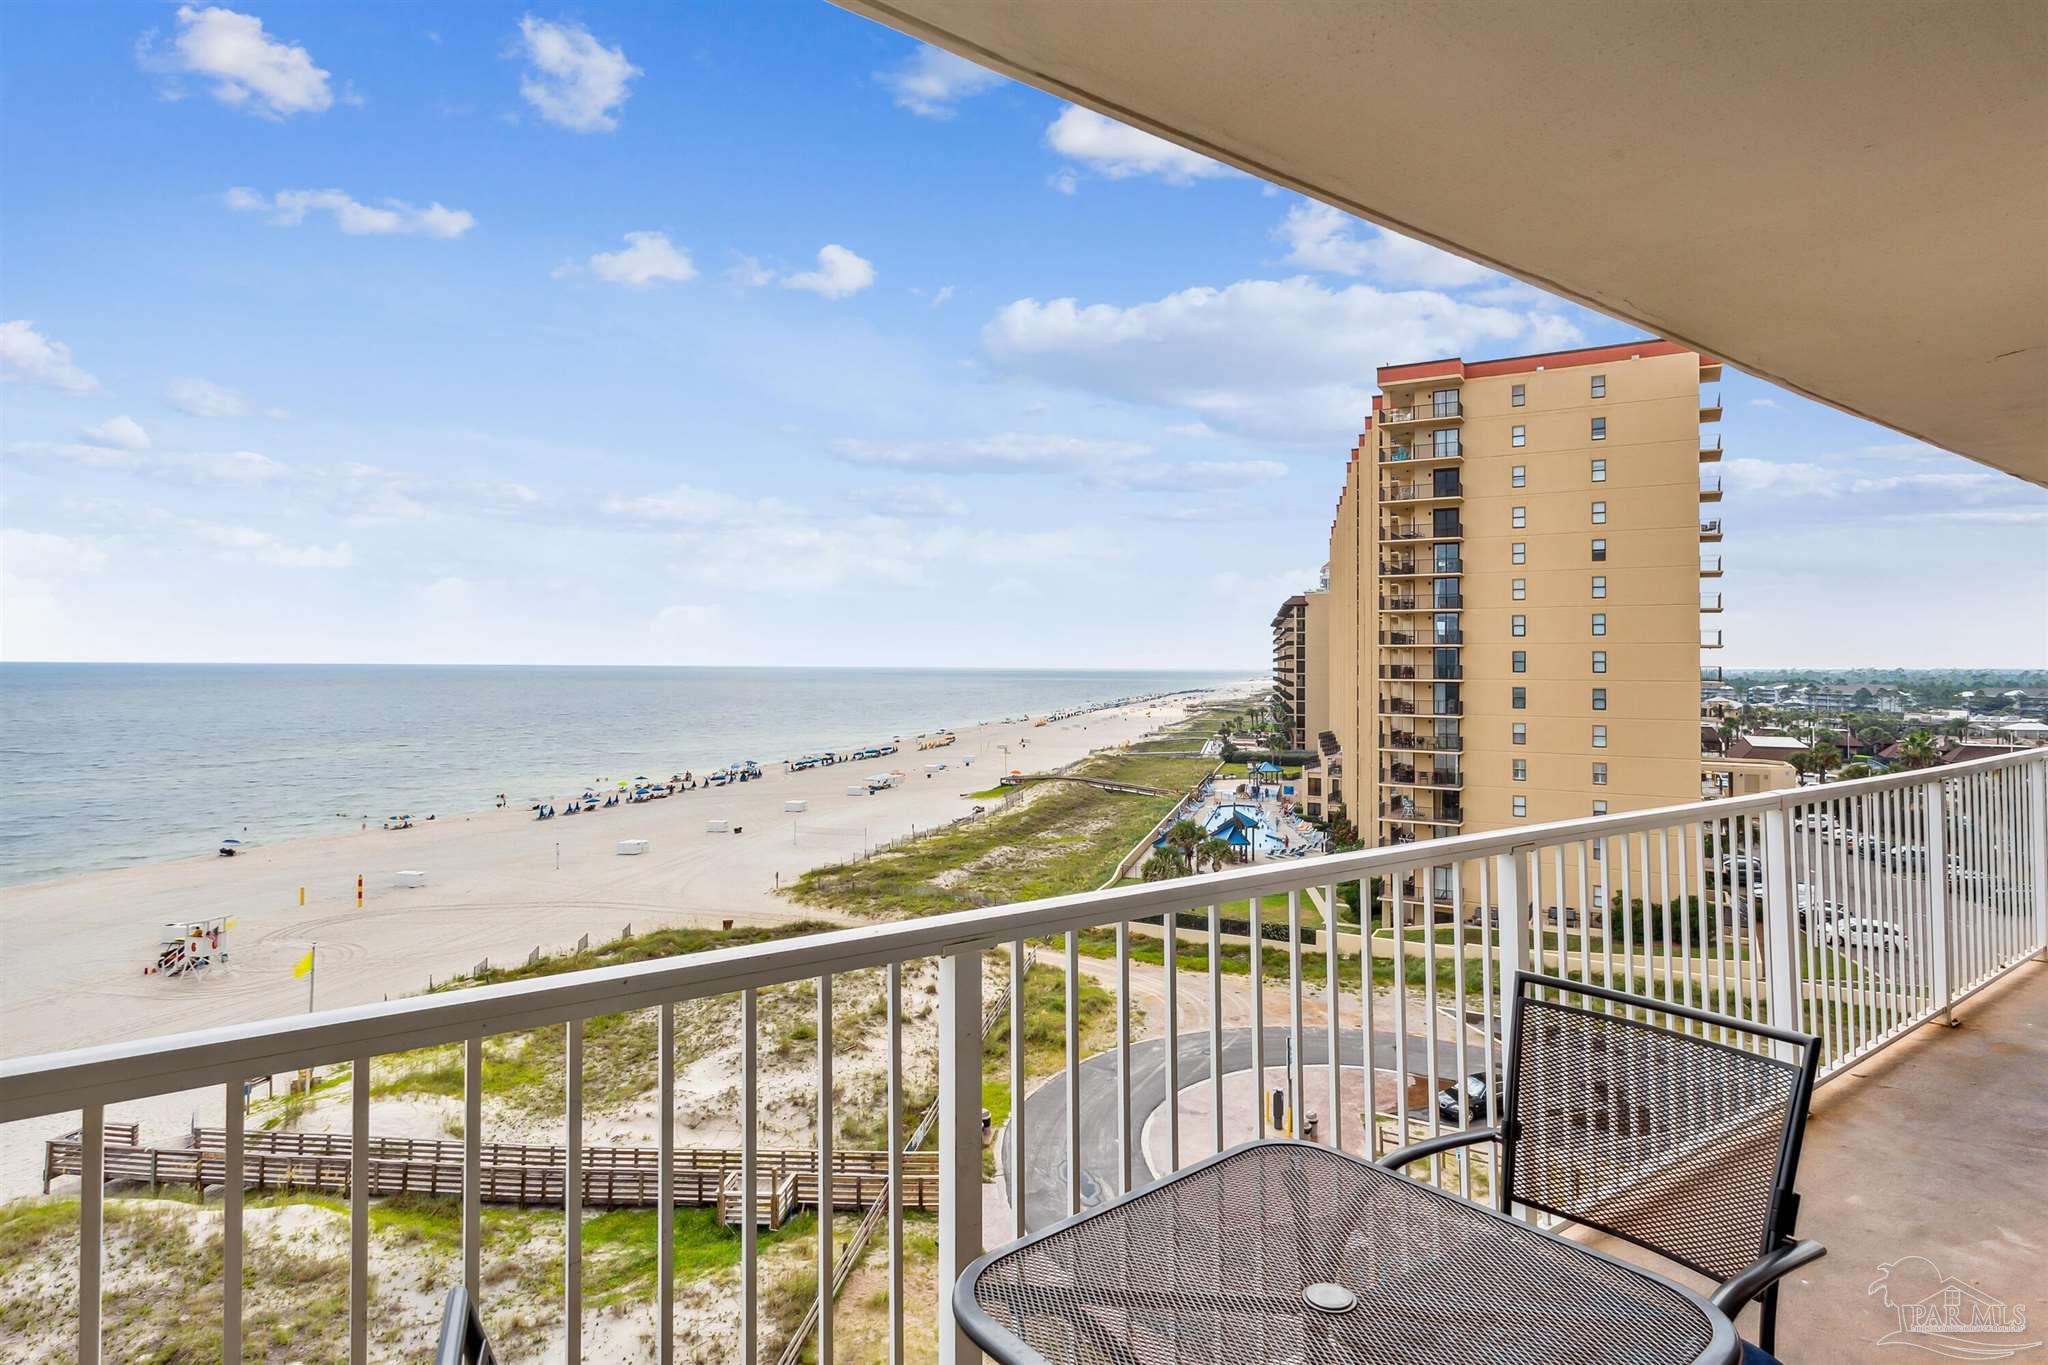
<box><xmin>43</xmin><ymin>1124</ymin><xmax>938</xmax><ymax>1212</ymax></box>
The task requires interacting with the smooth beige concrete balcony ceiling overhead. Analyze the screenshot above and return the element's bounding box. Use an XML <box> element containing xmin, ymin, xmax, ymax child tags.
<box><xmin>838</xmin><ymin>0</ymin><xmax>2048</xmax><ymax>485</ymax></box>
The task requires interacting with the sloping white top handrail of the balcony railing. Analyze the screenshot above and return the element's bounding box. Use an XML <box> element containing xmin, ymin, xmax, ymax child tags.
<box><xmin>0</xmin><ymin>749</ymin><xmax>2048</xmax><ymax>1124</ymax></box>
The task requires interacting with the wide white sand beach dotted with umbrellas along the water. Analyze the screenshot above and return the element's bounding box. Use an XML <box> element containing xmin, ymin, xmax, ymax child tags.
<box><xmin>0</xmin><ymin>700</ymin><xmax>1245</xmax><ymax>1197</ymax></box>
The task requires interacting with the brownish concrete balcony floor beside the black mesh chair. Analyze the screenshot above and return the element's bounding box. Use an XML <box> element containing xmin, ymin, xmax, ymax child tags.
<box><xmin>1589</xmin><ymin>962</ymin><xmax>2048</xmax><ymax>1365</ymax></box>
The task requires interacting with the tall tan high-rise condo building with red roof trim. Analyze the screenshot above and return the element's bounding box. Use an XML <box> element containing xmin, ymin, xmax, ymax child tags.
<box><xmin>1310</xmin><ymin>342</ymin><xmax>1720</xmax><ymax>843</ymax></box>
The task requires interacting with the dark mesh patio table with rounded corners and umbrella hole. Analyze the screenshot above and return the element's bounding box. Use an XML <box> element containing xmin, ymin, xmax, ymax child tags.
<box><xmin>954</xmin><ymin>1142</ymin><xmax>1741</xmax><ymax>1365</ymax></box>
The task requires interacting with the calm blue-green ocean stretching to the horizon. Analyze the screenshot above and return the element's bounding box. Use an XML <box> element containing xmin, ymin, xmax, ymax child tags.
<box><xmin>0</xmin><ymin>663</ymin><xmax>1249</xmax><ymax>886</ymax></box>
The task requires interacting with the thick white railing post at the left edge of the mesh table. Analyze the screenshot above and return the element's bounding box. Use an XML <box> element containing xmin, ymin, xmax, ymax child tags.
<box><xmin>938</xmin><ymin>948</ymin><xmax>983</xmax><ymax>1365</ymax></box>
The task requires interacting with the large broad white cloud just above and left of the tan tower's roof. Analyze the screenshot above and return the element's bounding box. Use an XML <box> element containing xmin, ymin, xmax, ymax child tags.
<box><xmin>981</xmin><ymin>276</ymin><xmax>1581</xmax><ymax>444</ymax></box>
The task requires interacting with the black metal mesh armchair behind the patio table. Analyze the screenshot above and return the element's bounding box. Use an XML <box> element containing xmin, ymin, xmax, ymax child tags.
<box><xmin>1380</xmin><ymin>972</ymin><xmax>1827</xmax><ymax>1353</ymax></box>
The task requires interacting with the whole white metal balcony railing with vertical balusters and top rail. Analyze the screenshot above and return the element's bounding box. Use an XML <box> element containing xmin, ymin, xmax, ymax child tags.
<box><xmin>0</xmin><ymin>749</ymin><xmax>2048</xmax><ymax>1363</ymax></box>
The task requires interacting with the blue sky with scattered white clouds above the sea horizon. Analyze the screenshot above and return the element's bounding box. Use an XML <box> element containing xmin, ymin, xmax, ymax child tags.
<box><xmin>0</xmin><ymin>4</ymin><xmax>2048</xmax><ymax>669</ymax></box>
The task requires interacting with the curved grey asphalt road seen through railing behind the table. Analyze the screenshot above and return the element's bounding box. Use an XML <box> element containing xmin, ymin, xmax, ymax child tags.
<box><xmin>1004</xmin><ymin>1019</ymin><xmax>1481</xmax><ymax>1228</ymax></box>
